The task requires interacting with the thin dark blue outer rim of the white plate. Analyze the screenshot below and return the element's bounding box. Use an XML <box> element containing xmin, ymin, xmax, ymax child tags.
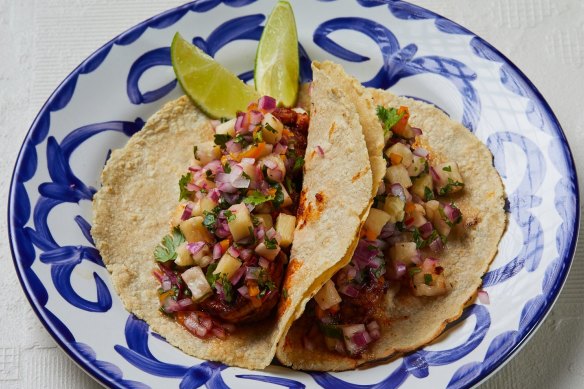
<box><xmin>7</xmin><ymin>0</ymin><xmax>580</xmax><ymax>387</ymax></box>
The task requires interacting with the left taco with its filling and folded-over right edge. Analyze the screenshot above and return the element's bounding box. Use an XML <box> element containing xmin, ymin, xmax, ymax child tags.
<box><xmin>92</xmin><ymin>77</ymin><xmax>372</xmax><ymax>369</ymax></box>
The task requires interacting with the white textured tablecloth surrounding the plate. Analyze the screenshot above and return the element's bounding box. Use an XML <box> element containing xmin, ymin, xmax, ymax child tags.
<box><xmin>0</xmin><ymin>0</ymin><xmax>584</xmax><ymax>389</ymax></box>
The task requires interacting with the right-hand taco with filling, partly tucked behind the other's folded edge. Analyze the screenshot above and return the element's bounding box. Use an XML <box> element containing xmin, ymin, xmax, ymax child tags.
<box><xmin>276</xmin><ymin>64</ymin><xmax>506</xmax><ymax>371</ymax></box>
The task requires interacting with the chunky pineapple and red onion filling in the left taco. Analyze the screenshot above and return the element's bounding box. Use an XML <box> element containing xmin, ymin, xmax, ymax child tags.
<box><xmin>153</xmin><ymin>96</ymin><xmax>309</xmax><ymax>339</ymax></box>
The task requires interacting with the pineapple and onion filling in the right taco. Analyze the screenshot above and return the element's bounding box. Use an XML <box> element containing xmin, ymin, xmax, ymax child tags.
<box><xmin>303</xmin><ymin>102</ymin><xmax>464</xmax><ymax>357</ymax></box>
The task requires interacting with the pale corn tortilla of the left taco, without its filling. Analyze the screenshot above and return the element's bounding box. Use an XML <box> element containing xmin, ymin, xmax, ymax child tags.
<box><xmin>92</xmin><ymin>59</ymin><xmax>373</xmax><ymax>369</ymax></box>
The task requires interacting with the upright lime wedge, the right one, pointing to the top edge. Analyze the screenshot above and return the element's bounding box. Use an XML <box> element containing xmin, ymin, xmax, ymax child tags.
<box><xmin>254</xmin><ymin>0</ymin><xmax>300</xmax><ymax>107</ymax></box>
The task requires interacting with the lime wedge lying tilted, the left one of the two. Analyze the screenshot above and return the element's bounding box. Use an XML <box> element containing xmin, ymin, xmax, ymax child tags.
<box><xmin>170</xmin><ymin>32</ymin><xmax>259</xmax><ymax>118</ymax></box>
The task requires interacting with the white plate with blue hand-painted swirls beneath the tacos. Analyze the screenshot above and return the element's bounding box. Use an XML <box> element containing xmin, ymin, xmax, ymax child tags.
<box><xmin>8</xmin><ymin>0</ymin><xmax>579</xmax><ymax>388</ymax></box>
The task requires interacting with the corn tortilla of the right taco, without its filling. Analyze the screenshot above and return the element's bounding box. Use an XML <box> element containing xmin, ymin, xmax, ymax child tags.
<box><xmin>276</xmin><ymin>67</ymin><xmax>506</xmax><ymax>371</ymax></box>
